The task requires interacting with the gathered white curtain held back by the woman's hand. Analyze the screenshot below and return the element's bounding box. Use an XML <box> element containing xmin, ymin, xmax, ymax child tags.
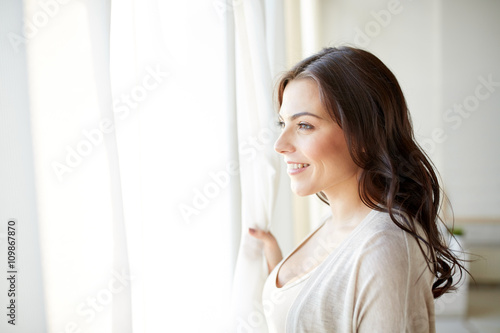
<box><xmin>231</xmin><ymin>0</ymin><xmax>284</xmax><ymax>332</ymax></box>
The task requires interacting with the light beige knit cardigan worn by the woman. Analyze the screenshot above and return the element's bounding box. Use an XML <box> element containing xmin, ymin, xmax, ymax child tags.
<box><xmin>286</xmin><ymin>211</ymin><xmax>435</xmax><ymax>333</ymax></box>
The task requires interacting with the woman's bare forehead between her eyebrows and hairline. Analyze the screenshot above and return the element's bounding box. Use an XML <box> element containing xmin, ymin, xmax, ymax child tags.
<box><xmin>279</xmin><ymin>78</ymin><xmax>327</xmax><ymax>118</ymax></box>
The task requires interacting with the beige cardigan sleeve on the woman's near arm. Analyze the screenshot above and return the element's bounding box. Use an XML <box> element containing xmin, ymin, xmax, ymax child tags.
<box><xmin>353</xmin><ymin>230</ymin><xmax>435</xmax><ymax>333</ymax></box>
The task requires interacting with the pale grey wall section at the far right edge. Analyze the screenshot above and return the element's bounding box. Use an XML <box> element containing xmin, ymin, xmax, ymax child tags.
<box><xmin>441</xmin><ymin>0</ymin><xmax>500</xmax><ymax>219</ymax></box>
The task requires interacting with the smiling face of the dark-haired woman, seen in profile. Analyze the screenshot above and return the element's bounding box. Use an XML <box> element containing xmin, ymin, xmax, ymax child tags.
<box><xmin>274</xmin><ymin>79</ymin><xmax>360</xmax><ymax>196</ymax></box>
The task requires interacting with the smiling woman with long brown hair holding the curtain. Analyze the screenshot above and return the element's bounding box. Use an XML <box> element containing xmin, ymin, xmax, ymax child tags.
<box><xmin>249</xmin><ymin>47</ymin><xmax>464</xmax><ymax>333</ymax></box>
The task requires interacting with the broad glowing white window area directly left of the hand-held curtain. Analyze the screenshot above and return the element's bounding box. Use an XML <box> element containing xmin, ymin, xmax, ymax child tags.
<box><xmin>111</xmin><ymin>0</ymin><xmax>232</xmax><ymax>333</ymax></box>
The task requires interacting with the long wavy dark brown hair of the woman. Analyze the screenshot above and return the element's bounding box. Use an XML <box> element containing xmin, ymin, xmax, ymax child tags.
<box><xmin>276</xmin><ymin>46</ymin><xmax>467</xmax><ymax>298</ymax></box>
